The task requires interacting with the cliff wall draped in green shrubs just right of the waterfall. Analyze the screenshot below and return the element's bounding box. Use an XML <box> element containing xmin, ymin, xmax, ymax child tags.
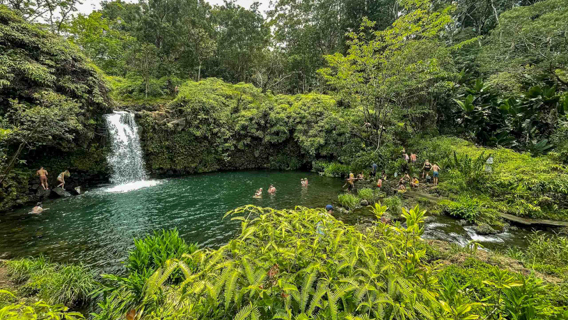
<box><xmin>137</xmin><ymin>79</ymin><xmax>360</xmax><ymax>174</ymax></box>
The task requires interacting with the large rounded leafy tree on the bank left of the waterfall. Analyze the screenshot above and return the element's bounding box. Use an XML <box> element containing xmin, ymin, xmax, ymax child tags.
<box><xmin>0</xmin><ymin>5</ymin><xmax>112</xmax><ymax>210</ymax></box>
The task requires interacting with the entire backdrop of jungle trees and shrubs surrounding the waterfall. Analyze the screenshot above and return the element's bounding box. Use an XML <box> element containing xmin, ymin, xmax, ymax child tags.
<box><xmin>0</xmin><ymin>0</ymin><xmax>568</xmax><ymax>208</ymax></box>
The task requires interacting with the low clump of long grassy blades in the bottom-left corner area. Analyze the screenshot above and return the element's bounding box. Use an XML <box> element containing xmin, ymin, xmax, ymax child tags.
<box><xmin>6</xmin><ymin>257</ymin><xmax>97</xmax><ymax>307</ymax></box>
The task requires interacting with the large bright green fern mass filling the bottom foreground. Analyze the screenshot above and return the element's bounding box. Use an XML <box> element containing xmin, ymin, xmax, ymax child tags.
<box><xmin>95</xmin><ymin>206</ymin><xmax>568</xmax><ymax>320</ymax></box>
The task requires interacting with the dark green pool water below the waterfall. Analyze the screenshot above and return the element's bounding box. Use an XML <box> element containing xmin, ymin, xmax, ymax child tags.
<box><xmin>0</xmin><ymin>171</ymin><xmax>343</xmax><ymax>271</ymax></box>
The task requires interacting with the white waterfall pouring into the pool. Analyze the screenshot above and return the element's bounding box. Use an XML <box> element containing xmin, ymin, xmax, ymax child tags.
<box><xmin>105</xmin><ymin>111</ymin><xmax>148</xmax><ymax>184</ymax></box>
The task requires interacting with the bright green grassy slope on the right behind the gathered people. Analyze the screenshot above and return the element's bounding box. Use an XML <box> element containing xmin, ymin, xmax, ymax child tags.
<box><xmin>413</xmin><ymin>137</ymin><xmax>568</xmax><ymax>220</ymax></box>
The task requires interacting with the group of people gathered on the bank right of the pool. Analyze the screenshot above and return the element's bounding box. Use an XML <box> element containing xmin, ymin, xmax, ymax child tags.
<box><xmin>343</xmin><ymin>150</ymin><xmax>441</xmax><ymax>192</ymax></box>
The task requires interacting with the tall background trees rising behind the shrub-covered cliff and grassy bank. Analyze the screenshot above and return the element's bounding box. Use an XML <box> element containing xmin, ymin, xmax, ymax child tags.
<box><xmin>0</xmin><ymin>0</ymin><xmax>568</xmax><ymax>153</ymax></box>
